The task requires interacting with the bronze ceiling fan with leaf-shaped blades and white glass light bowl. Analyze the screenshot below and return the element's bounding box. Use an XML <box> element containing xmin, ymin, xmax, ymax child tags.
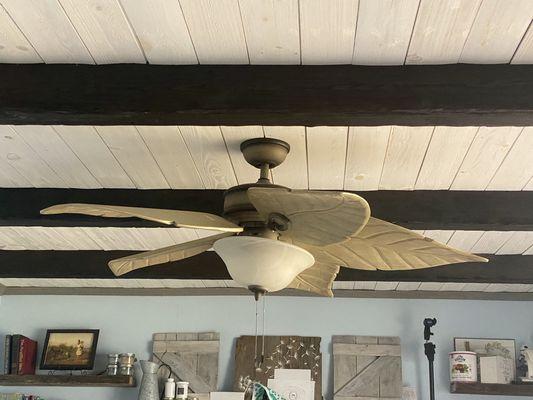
<box><xmin>41</xmin><ymin>138</ymin><xmax>488</xmax><ymax>298</ymax></box>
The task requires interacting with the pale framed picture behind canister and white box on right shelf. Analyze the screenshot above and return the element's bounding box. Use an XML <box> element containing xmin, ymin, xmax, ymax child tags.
<box><xmin>454</xmin><ymin>338</ymin><xmax>516</xmax><ymax>379</ymax></box>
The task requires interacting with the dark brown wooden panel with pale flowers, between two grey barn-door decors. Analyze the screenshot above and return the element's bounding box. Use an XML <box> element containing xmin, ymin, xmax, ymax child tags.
<box><xmin>234</xmin><ymin>336</ymin><xmax>322</xmax><ymax>400</ymax></box>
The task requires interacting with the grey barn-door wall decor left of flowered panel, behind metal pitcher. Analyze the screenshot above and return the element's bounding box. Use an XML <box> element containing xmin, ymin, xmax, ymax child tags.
<box><xmin>153</xmin><ymin>332</ymin><xmax>220</xmax><ymax>393</ymax></box>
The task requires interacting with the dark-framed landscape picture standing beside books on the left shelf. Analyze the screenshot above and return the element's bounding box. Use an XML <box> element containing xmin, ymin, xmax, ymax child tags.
<box><xmin>40</xmin><ymin>329</ymin><xmax>99</xmax><ymax>370</ymax></box>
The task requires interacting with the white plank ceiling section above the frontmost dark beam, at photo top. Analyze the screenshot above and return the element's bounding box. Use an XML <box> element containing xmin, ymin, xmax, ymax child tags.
<box><xmin>0</xmin><ymin>0</ymin><xmax>533</xmax><ymax>65</ymax></box>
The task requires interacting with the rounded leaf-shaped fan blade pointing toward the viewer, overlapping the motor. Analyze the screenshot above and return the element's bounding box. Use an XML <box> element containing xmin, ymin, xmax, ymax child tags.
<box><xmin>248</xmin><ymin>187</ymin><xmax>370</xmax><ymax>246</ymax></box>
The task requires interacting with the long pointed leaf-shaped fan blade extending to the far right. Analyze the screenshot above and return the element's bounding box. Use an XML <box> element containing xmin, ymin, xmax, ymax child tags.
<box><xmin>294</xmin><ymin>218</ymin><xmax>488</xmax><ymax>270</ymax></box>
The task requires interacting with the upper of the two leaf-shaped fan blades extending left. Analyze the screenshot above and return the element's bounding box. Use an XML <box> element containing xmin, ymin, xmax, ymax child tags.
<box><xmin>41</xmin><ymin>203</ymin><xmax>242</xmax><ymax>232</ymax></box>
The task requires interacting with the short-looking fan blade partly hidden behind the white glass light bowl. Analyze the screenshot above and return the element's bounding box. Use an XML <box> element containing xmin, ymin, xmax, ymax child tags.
<box><xmin>288</xmin><ymin>262</ymin><xmax>340</xmax><ymax>297</ymax></box>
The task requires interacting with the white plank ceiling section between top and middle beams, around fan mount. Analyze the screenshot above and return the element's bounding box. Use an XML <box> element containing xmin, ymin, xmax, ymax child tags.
<box><xmin>0</xmin><ymin>126</ymin><xmax>533</xmax><ymax>191</ymax></box>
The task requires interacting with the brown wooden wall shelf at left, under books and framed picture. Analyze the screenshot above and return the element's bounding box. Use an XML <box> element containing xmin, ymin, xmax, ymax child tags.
<box><xmin>0</xmin><ymin>375</ymin><xmax>136</xmax><ymax>387</ymax></box>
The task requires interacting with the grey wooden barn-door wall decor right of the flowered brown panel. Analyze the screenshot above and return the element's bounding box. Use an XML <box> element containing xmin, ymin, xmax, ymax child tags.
<box><xmin>333</xmin><ymin>336</ymin><xmax>402</xmax><ymax>400</ymax></box>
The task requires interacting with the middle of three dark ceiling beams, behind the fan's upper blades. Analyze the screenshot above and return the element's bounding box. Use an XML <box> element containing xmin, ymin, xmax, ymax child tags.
<box><xmin>0</xmin><ymin>189</ymin><xmax>533</xmax><ymax>231</ymax></box>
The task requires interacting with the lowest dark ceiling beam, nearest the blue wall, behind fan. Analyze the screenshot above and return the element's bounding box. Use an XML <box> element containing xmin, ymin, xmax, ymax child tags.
<box><xmin>0</xmin><ymin>250</ymin><xmax>533</xmax><ymax>284</ymax></box>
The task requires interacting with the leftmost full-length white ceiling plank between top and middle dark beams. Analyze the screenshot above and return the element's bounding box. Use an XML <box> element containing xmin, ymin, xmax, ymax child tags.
<box><xmin>14</xmin><ymin>125</ymin><xmax>102</xmax><ymax>188</ymax></box>
